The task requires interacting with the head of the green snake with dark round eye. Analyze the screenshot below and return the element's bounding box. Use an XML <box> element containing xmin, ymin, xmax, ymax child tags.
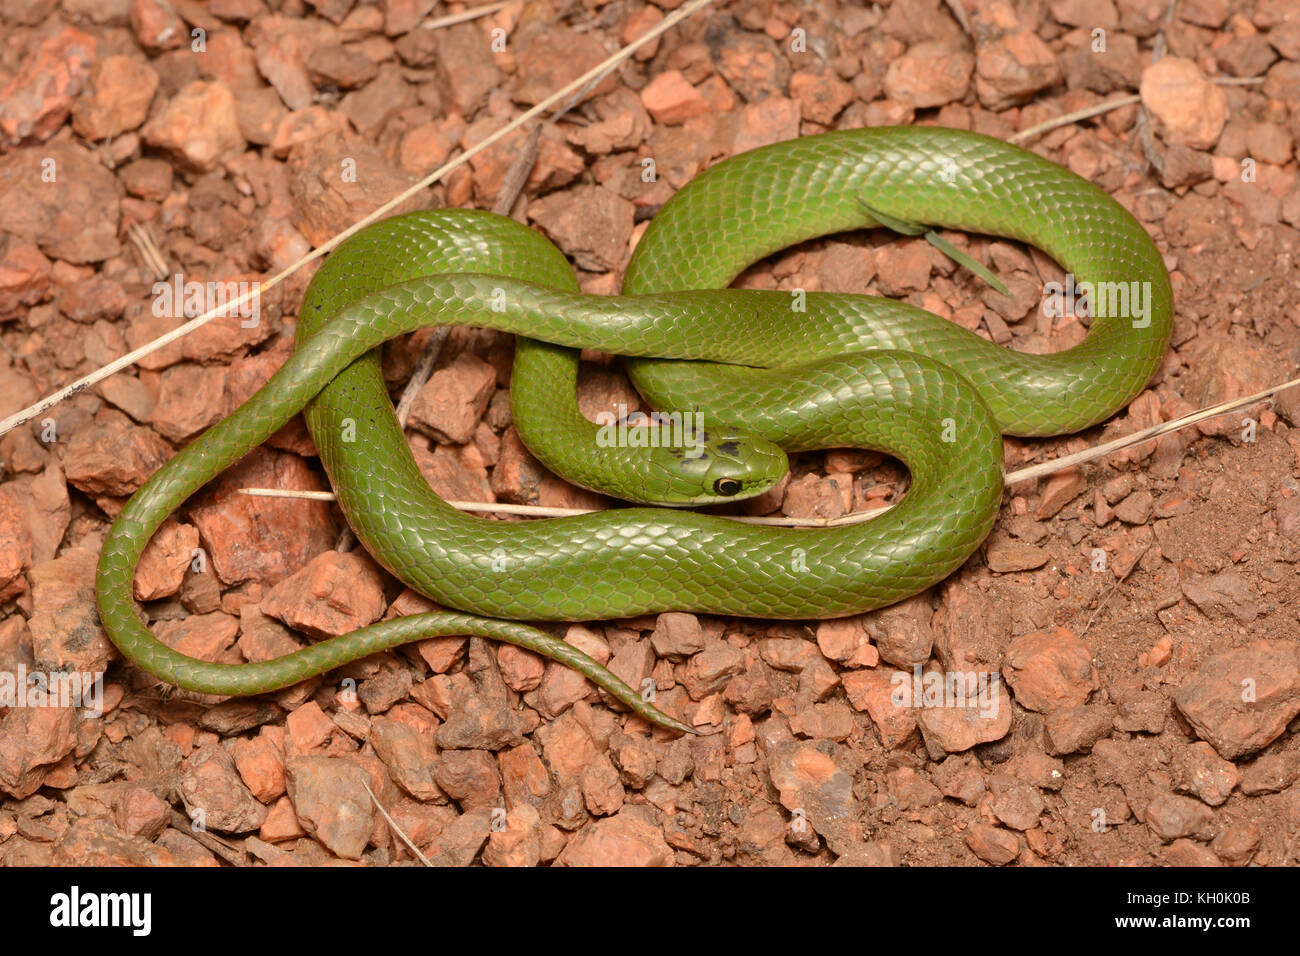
<box><xmin>645</xmin><ymin>428</ymin><xmax>789</xmax><ymax>507</ymax></box>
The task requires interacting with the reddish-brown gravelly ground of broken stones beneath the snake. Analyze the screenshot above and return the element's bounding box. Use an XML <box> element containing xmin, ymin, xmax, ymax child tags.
<box><xmin>0</xmin><ymin>0</ymin><xmax>1300</xmax><ymax>866</ymax></box>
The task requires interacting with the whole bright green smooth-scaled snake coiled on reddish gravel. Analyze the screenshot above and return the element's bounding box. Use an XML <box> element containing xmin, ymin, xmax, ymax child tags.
<box><xmin>98</xmin><ymin>127</ymin><xmax>1173</xmax><ymax>731</ymax></box>
